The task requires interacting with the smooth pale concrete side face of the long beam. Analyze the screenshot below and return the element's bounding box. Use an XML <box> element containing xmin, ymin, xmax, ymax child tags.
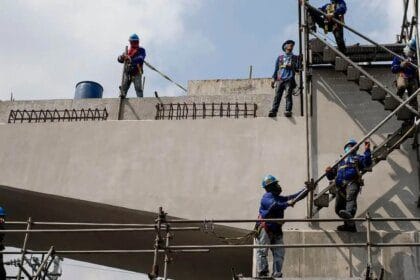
<box><xmin>0</xmin><ymin>118</ymin><xmax>306</xmax><ymax>225</ymax></box>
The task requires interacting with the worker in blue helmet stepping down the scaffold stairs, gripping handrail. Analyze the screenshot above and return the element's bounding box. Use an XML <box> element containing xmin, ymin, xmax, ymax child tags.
<box><xmin>326</xmin><ymin>139</ymin><xmax>372</xmax><ymax>232</ymax></box>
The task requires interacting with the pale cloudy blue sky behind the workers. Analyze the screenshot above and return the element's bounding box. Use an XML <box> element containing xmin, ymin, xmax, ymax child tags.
<box><xmin>0</xmin><ymin>0</ymin><xmax>408</xmax><ymax>100</ymax></box>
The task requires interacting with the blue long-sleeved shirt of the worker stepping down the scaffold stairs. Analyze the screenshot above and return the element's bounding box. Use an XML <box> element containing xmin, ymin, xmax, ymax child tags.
<box><xmin>327</xmin><ymin>149</ymin><xmax>372</xmax><ymax>187</ymax></box>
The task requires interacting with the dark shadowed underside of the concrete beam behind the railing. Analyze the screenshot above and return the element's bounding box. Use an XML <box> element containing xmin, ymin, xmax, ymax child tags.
<box><xmin>0</xmin><ymin>186</ymin><xmax>252</xmax><ymax>279</ymax></box>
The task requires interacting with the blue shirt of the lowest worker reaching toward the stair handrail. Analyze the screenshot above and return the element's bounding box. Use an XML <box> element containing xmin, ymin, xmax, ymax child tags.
<box><xmin>257</xmin><ymin>188</ymin><xmax>306</xmax><ymax>233</ymax></box>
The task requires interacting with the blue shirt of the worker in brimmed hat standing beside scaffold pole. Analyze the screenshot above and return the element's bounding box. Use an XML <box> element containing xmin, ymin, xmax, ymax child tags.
<box><xmin>273</xmin><ymin>53</ymin><xmax>300</xmax><ymax>81</ymax></box>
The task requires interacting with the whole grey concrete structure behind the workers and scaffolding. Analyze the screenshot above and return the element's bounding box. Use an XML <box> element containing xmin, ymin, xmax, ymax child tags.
<box><xmin>0</xmin><ymin>67</ymin><xmax>420</xmax><ymax>279</ymax></box>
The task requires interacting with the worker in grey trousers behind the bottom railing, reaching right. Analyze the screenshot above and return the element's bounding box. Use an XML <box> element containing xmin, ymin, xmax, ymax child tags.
<box><xmin>255</xmin><ymin>175</ymin><xmax>305</xmax><ymax>277</ymax></box>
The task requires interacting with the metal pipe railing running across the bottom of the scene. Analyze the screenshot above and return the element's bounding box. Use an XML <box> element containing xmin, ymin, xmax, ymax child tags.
<box><xmin>0</xmin><ymin>210</ymin><xmax>420</xmax><ymax>279</ymax></box>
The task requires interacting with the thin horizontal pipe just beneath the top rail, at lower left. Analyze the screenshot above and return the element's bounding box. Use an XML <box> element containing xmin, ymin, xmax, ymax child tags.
<box><xmin>0</xmin><ymin>227</ymin><xmax>200</xmax><ymax>233</ymax></box>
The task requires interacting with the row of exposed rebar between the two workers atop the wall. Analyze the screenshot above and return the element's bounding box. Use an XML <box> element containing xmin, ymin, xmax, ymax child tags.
<box><xmin>155</xmin><ymin>102</ymin><xmax>258</xmax><ymax>120</ymax></box>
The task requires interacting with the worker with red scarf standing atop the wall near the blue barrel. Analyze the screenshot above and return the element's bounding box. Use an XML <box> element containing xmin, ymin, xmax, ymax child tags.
<box><xmin>118</xmin><ymin>34</ymin><xmax>146</xmax><ymax>98</ymax></box>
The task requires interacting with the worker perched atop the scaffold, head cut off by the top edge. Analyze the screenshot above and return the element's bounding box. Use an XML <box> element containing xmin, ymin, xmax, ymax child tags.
<box><xmin>301</xmin><ymin>0</ymin><xmax>347</xmax><ymax>54</ymax></box>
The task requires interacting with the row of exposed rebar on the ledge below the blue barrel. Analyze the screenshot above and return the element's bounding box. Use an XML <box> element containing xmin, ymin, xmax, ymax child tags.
<box><xmin>8</xmin><ymin>108</ymin><xmax>109</xmax><ymax>123</ymax></box>
